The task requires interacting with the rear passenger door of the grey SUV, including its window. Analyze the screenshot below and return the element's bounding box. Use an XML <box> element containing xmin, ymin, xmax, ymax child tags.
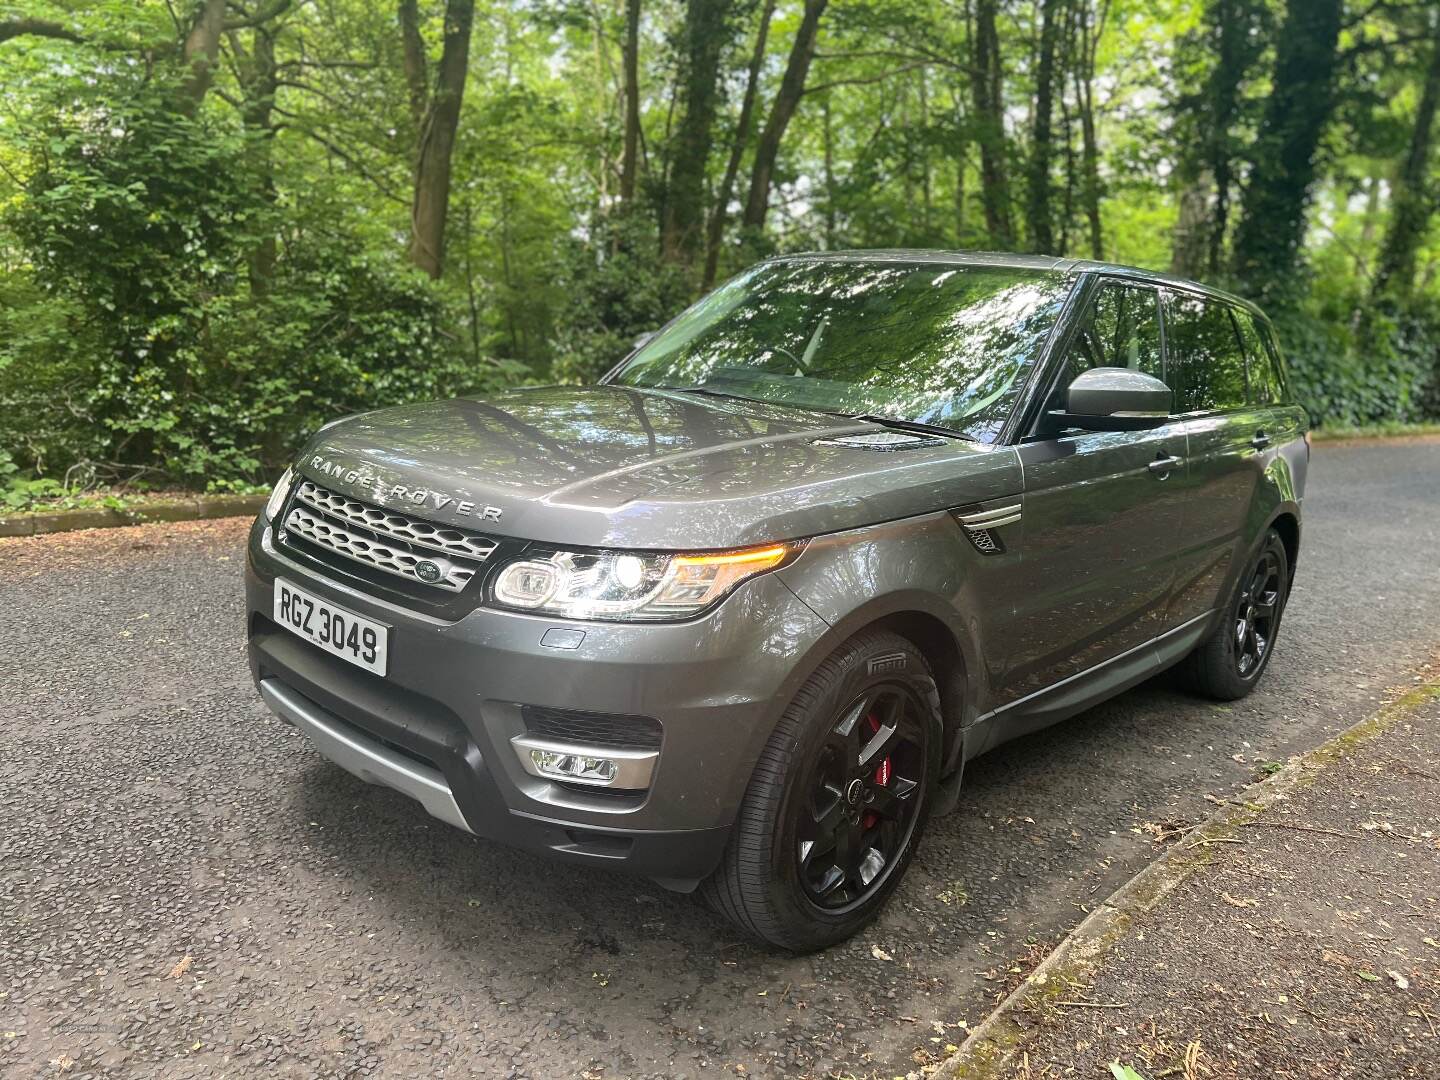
<box><xmin>1165</xmin><ymin>289</ymin><xmax>1270</xmax><ymax>629</ymax></box>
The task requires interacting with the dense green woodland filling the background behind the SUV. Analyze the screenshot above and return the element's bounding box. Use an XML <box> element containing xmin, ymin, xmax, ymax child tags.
<box><xmin>0</xmin><ymin>0</ymin><xmax>1440</xmax><ymax>487</ymax></box>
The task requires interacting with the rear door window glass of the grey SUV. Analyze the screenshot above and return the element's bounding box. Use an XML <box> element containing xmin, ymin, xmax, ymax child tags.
<box><xmin>1165</xmin><ymin>292</ymin><xmax>1248</xmax><ymax>413</ymax></box>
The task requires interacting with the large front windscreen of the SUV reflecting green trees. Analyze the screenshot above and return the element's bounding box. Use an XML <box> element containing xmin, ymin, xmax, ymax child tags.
<box><xmin>613</xmin><ymin>261</ymin><xmax>1071</xmax><ymax>442</ymax></box>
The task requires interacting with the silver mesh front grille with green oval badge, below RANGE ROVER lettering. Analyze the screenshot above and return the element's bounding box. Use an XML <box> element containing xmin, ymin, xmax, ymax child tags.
<box><xmin>282</xmin><ymin>480</ymin><xmax>495</xmax><ymax>592</ymax></box>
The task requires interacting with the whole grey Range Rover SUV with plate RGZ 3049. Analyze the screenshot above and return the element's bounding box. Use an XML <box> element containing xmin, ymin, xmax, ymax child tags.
<box><xmin>246</xmin><ymin>252</ymin><xmax>1309</xmax><ymax>949</ymax></box>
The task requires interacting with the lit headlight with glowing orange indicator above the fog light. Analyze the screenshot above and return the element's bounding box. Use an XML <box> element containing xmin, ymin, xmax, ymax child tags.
<box><xmin>491</xmin><ymin>544</ymin><xmax>796</xmax><ymax>622</ymax></box>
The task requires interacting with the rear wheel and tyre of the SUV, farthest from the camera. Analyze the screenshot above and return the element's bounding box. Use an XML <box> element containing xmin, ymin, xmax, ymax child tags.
<box><xmin>1179</xmin><ymin>528</ymin><xmax>1290</xmax><ymax>701</ymax></box>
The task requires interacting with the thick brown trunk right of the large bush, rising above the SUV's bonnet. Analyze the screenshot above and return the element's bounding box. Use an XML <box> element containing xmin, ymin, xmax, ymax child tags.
<box><xmin>410</xmin><ymin>0</ymin><xmax>475</xmax><ymax>279</ymax></box>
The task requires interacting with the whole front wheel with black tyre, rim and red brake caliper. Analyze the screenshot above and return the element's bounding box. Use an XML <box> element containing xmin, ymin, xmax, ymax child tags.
<box><xmin>701</xmin><ymin>632</ymin><xmax>943</xmax><ymax>952</ymax></box>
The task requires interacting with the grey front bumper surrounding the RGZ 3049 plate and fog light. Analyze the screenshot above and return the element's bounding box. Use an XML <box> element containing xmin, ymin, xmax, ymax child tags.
<box><xmin>246</xmin><ymin>523</ymin><xmax>828</xmax><ymax>888</ymax></box>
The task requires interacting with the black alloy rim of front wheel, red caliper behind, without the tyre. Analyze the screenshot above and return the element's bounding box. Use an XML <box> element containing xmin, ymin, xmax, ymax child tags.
<box><xmin>795</xmin><ymin>683</ymin><xmax>929</xmax><ymax>912</ymax></box>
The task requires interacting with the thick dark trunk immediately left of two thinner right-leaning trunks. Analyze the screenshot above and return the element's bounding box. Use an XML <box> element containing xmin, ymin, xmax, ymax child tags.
<box><xmin>661</xmin><ymin>0</ymin><xmax>733</xmax><ymax>265</ymax></box>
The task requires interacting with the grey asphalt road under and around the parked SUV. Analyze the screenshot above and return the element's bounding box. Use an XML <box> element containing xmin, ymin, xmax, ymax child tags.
<box><xmin>0</xmin><ymin>442</ymin><xmax>1440</xmax><ymax>1077</ymax></box>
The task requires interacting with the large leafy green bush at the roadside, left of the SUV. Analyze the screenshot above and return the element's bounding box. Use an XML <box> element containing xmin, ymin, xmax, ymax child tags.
<box><xmin>0</xmin><ymin>70</ymin><xmax>514</xmax><ymax>488</ymax></box>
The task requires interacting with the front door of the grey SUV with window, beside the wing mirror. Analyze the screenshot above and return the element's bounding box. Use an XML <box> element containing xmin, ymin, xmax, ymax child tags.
<box><xmin>1001</xmin><ymin>279</ymin><xmax>1187</xmax><ymax>704</ymax></box>
